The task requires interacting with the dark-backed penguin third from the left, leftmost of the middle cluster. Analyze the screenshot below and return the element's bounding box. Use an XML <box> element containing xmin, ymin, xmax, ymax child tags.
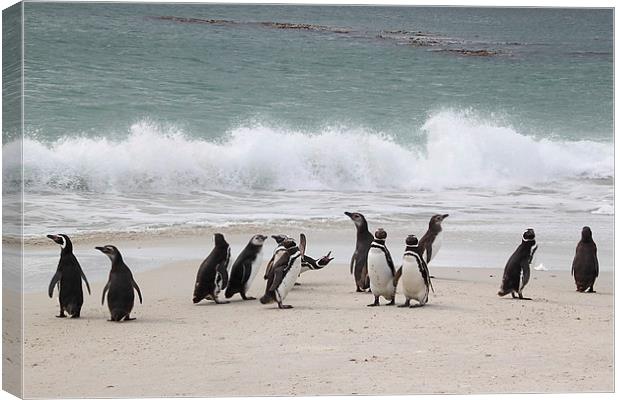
<box><xmin>193</xmin><ymin>233</ymin><xmax>230</xmax><ymax>304</ymax></box>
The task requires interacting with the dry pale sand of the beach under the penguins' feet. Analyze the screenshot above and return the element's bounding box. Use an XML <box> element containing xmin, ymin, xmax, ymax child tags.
<box><xmin>24</xmin><ymin>260</ymin><xmax>614</xmax><ymax>397</ymax></box>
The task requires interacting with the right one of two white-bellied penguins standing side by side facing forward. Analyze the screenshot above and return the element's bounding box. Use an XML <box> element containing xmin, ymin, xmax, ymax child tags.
<box><xmin>394</xmin><ymin>235</ymin><xmax>435</xmax><ymax>307</ymax></box>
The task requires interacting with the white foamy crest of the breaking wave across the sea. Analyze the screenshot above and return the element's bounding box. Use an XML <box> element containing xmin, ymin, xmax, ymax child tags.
<box><xmin>4</xmin><ymin>111</ymin><xmax>613</xmax><ymax>192</ymax></box>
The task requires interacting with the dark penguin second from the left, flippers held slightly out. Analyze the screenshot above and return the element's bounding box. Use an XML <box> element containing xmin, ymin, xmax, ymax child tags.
<box><xmin>95</xmin><ymin>245</ymin><xmax>142</xmax><ymax>322</ymax></box>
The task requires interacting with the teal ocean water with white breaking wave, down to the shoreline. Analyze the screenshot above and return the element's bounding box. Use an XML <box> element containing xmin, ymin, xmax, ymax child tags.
<box><xmin>3</xmin><ymin>2</ymin><xmax>614</xmax><ymax>282</ymax></box>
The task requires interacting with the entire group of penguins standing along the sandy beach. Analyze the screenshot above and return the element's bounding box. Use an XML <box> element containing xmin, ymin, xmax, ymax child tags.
<box><xmin>47</xmin><ymin>212</ymin><xmax>599</xmax><ymax>322</ymax></box>
